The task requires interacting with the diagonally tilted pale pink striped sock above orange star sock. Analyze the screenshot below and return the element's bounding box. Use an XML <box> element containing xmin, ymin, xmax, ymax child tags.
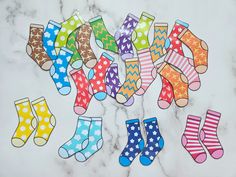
<box><xmin>165</xmin><ymin>50</ymin><xmax>201</xmax><ymax>91</ymax></box>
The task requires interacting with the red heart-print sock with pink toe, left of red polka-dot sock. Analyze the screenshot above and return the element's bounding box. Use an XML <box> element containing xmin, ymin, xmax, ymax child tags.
<box><xmin>70</xmin><ymin>68</ymin><xmax>92</xmax><ymax>115</ymax></box>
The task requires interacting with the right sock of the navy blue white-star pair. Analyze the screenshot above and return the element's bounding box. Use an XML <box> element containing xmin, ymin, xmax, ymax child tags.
<box><xmin>139</xmin><ymin>117</ymin><xmax>164</xmax><ymax>166</ymax></box>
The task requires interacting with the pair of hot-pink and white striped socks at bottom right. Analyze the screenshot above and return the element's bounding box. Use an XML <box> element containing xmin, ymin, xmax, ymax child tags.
<box><xmin>181</xmin><ymin>109</ymin><xmax>224</xmax><ymax>164</ymax></box>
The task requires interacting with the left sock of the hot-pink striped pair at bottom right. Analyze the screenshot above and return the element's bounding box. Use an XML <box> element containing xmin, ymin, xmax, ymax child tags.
<box><xmin>182</xmin><ymin>115</ymin><xmax>207</xmax><ymax>163</ymax></box>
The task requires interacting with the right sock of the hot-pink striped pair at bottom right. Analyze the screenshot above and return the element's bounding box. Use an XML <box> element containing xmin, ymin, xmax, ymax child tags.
<box><xmin>200</xmin><ymin>109</ymin><xmax>224</xmax><ymax>159</ymax></box>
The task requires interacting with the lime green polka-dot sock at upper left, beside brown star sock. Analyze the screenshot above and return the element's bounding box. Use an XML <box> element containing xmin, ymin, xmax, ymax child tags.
<box><xmin>55</xmin><ymin>11</ymin><xmax>84</xmax><ymax>53</ymax></box>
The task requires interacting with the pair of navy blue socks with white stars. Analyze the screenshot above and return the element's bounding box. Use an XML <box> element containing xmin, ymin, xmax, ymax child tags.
<box><xmin>119</xmin><ymin>117</ymin><xmax>164</xmax><ymax>167</ymax></box>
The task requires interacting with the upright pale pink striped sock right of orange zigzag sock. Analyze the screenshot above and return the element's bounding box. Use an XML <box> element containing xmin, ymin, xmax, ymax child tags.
<box><xmin>135</xmin><ymin>49</ymin><xmax>157</xmax><ymax>95</ymax></box>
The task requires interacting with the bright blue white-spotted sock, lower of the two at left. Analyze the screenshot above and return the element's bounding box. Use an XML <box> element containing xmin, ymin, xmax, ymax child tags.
<box><xmin>50</xmin><ymin>47</ymin><xmax>73</xmax><ymax>95</ymax></box>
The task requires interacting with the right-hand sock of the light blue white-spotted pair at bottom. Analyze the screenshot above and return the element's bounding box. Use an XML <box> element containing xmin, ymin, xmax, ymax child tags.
<box><xmin>75</xmin><ymin>117</ymin><xmax>103</xmax><ymax>162</ymax></box>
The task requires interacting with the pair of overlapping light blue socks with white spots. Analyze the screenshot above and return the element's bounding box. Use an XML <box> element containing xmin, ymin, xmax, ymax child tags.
<box><xmin>58</xmin><ymin>117</ymin><xmax>103</xmax><ymax>162</ymax></box>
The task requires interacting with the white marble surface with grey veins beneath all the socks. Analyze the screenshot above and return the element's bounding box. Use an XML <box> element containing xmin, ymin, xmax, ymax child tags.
<box><xmin>0</xmin><ymin>0</ymin><xmax>236</xmax><ymax>177</ymax></box>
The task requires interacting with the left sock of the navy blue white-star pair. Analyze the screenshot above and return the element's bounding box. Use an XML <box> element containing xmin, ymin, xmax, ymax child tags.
<box><xmin>119</xmin><ymin>119</ymin><xmax>144</xmax><ymax>166</ymax></box>
